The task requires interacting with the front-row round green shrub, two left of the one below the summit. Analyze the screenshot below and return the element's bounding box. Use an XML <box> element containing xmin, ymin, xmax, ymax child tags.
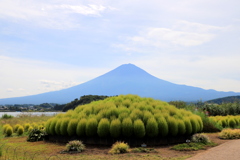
<box><xmin>97</xmin><ymin>118</ymin><xmax>110</xmax><ymax>137</ymax></box>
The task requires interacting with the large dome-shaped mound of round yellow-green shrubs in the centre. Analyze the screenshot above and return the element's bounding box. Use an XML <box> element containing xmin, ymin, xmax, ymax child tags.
<box><xmin>45</xmin><ymin>95</ymin><xmax>203</xmax><ymax>138</ymax></box>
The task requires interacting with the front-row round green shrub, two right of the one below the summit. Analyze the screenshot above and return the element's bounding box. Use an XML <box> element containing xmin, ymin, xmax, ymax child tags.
<box><xmin>146</xmin><ymin>117</ymin><xmax>158</xmax><ymax>137</ymax></box>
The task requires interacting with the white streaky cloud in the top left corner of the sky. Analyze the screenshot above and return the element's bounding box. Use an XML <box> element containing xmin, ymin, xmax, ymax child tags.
<box><xmin>0</xmin><ymin>0</ymin><xmax>113</xmax><ymax>29</ymax></box>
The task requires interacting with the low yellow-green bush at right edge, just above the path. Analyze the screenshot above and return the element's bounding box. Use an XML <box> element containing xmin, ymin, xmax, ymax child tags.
<box><xmin>219</xmin><ymin>128</ymin><xmax>240</xmax><ymax>139</ymax></box>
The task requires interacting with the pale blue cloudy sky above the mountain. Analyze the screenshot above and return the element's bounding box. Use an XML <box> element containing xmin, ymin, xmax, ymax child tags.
<box><xmin>0</xmin><ymin>0</ymin><xmax>240</xmax><ymax>98</ymax></box>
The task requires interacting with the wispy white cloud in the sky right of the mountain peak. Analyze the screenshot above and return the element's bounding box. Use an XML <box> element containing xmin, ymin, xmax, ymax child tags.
<box><xmin>117</xmin><ymin>21</ymin><xmax>228</xmax><ymax>53</ymax></box>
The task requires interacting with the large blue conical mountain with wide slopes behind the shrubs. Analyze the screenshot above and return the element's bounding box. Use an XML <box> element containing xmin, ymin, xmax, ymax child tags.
<box><xmin>0</xmin><ymin>64</ymin><xmax>240</xmax><ymax>104</ymax></box>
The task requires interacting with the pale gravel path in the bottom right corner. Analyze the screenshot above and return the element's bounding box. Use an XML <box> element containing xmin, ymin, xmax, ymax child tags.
<box><xmin>187</xmin><ymin>140</ymin><xmax>240</xmax><ymax>160</ymax></box>
